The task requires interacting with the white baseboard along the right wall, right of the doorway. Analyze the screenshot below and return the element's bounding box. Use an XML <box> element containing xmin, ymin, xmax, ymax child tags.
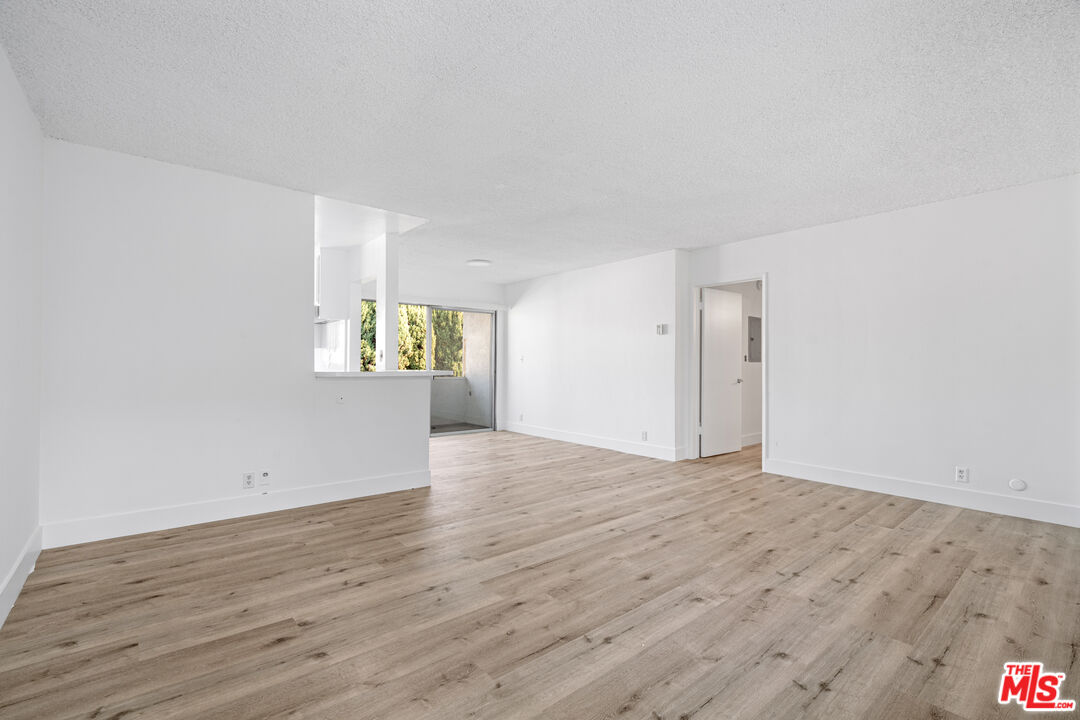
<box><xmin>764</xmin><ymin>459</ymin><xmax>1080</xmax><ymax>528</ymax></box>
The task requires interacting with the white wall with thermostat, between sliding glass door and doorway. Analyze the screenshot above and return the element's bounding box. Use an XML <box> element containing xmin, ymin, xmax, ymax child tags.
<box><xmin>507</xmin><ymin>252</ymin><xmax>685</xmax><ymax>460</ymax></box>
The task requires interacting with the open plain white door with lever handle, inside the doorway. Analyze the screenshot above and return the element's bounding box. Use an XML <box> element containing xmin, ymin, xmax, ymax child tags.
<box><xmin>701</xmin><ymin>287</ymin><xmax>742</xmax><ymax>458</ymax></box>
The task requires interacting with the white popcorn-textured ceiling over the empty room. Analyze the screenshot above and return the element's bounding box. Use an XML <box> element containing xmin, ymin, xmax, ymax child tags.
<box><xmin>0</xmin><ymin>0</ymin><xmax>1080</xmax><ymax>282</ymax></box>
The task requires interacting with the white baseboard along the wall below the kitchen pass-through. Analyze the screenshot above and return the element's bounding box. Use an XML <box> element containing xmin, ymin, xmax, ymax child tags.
<box><xmin>42</xmin><ymin>470</ymin><xmax>431</xmax><ymax>547</ymax></box>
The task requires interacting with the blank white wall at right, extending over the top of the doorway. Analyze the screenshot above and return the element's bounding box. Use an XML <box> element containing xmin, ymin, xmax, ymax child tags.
<box><xmin>695</xmin><ymin>176</ymin><xmax>1080</xmax><ymax>525</ymax></box>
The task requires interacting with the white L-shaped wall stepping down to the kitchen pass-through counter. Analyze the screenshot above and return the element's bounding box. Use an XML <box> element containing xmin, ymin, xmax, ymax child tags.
<box><xmin>41</xmin><ymin>140</ymin><xmax>430</xmax><ymax>546</ymax></box>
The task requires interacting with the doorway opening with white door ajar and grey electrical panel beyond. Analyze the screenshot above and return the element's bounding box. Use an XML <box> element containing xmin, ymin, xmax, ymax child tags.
<box><xmin>697</xmin><ymin>280</ymin><xmax>765</xmax><ymax>458</ymax></box>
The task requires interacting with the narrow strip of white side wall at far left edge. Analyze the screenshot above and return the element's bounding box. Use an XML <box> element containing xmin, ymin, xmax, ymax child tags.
<box><xmin>0</xmin><ymin>42</ymin><xmax>41</xmax><ymax>624</ymax></box>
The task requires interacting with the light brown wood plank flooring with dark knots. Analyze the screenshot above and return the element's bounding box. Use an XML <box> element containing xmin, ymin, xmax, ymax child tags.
<box><xmin>0</xmin><ymin>433</ymin><xmax>1080</xmax><ymax>720</ymax></box>
